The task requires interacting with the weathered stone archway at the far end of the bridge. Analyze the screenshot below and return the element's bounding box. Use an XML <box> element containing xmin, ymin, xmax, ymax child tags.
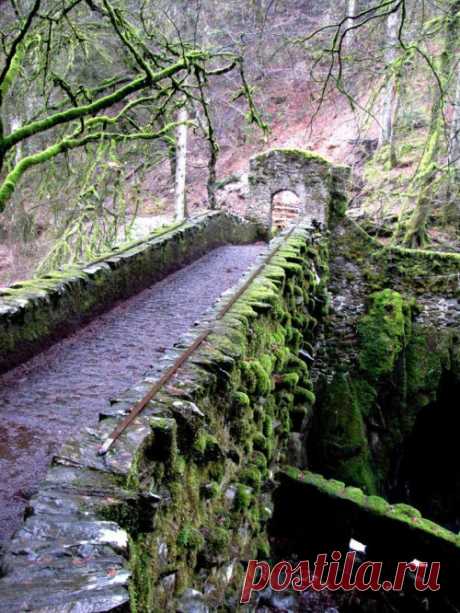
<box><xmin>247</xmin><ymin>149</ymin><xmax>349</xmax><ymax>235</ymax></box>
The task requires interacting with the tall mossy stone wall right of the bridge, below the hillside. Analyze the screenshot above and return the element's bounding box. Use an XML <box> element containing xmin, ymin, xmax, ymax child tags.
<box><xmin>309</xmin><ymin>215</ymin><xmax>460</xmax><ymax>502</ymax></box>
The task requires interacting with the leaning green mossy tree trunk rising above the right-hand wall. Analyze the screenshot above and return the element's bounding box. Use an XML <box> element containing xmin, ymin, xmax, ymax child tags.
<box><xmin>404</xmin><ymin>0</ymin><xmax>460</xmax><ymax>248</ymax></box>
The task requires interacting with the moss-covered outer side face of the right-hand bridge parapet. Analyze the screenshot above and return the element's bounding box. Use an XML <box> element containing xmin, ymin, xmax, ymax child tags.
<box><xmin>124</xmin><ymin>222</ymin><xmax>327</xmax><ymax>611</ymax></box>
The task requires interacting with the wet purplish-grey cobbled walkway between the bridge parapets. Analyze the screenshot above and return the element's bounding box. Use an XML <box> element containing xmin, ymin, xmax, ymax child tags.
<box><xmin>0</xmin><ymin>243</ymin><xmax>267</xmax><ymax>547</ymax></box>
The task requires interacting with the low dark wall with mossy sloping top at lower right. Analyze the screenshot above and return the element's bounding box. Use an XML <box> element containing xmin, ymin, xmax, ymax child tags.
<box><xmin>274</xmin><ymin>467</ymin><xmax>460</xmax><ymax>602</ymax></box>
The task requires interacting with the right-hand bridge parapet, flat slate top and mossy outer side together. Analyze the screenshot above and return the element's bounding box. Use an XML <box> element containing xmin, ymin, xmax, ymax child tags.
<box><xmin>0</xmin><ymin>219</ymin><xmax>328</xmax><ymax>613</ymax></box>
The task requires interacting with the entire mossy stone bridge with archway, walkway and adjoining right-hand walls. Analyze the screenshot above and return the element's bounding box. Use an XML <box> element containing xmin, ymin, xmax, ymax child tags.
<box><xmin>0</xmin><ymin>150</ymin><xmax>460</xmax><ymax>613</ymax></box>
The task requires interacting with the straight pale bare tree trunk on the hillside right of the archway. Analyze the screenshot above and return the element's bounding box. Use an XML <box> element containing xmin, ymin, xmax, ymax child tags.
<box><xmin>379</xmin><ymin>11</ymin><xmax>401</xmax><ymax>168</ymax></box>
